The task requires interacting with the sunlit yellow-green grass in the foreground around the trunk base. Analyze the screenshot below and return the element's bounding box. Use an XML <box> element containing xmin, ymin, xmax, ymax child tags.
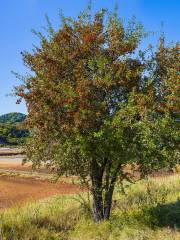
<box><xmin>0</xmin><ymin>175</ymin><xmax>180</xmax><ymax>240</ymax></box>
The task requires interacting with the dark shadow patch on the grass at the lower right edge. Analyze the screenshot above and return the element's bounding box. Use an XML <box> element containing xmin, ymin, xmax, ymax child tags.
<box><xmin>148</xmin><ymin>199</ymin><xmax>180</xmax><ymax>230</ymax></box>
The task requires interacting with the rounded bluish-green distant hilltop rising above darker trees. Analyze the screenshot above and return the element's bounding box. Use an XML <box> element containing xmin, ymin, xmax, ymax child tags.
<box><xmin>0</xmin><ymin>112</ymin><xmax>26</xmax><ymax>124</ymax></box>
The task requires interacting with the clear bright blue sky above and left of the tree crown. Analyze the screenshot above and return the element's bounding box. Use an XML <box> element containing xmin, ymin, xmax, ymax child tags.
<box><xmin>0</xmin><ymin>0</ymin><xmax>180</xmax><ymax>115</ymax></box>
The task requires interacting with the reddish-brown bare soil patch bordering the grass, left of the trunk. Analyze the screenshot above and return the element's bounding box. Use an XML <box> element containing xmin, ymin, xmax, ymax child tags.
<box><xmin>0</xmin><ymin>176</ymin><xmax>82</xmax><ymax>209</ymax></box>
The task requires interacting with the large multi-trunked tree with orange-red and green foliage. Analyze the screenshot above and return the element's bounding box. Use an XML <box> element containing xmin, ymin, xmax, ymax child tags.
<box><xmin>15</xmin><ymin>5</ymin><xmax>179</xmax><ymax>222</ymax></box>
